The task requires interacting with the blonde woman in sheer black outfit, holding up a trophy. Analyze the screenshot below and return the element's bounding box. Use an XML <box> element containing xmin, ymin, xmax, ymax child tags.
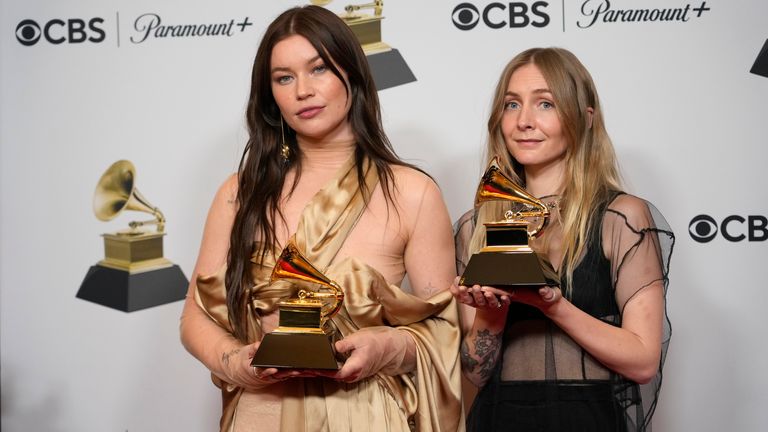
<box><xmin>451</xmin><ymin>48</ymin><xmax>674</xmax><ymax>431</ymax></box>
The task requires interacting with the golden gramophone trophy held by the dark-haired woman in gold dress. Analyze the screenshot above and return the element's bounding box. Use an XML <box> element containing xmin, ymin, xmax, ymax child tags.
<box><xmin>251</xmin><ymin>242</ymin><xmax>344</xmax><ymax>370</ymax></box>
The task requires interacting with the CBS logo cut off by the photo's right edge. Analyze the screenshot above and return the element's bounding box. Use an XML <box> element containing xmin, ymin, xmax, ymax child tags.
<box><xmin>688</xmin><ymin>214</ymin><xmax>768</xmax><ymax>243</ymax></box>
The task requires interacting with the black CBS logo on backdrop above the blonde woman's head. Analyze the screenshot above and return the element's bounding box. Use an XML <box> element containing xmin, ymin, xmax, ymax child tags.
<box><xmin>451</xmin><ymin>1</ymin><xmax>549</xmax><ymax>30</ymax></box>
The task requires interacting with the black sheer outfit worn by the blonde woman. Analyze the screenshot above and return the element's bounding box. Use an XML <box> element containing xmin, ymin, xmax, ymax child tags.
<box><xmin>455</xmin><ymin>193</ymin><xmax>674</xmax><ymax>432</ymax></box>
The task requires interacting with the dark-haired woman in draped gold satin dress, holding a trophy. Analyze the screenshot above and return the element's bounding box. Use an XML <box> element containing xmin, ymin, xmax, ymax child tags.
<box><xmin>181</xmin><ymin>6</ymin><xmax>463</xmax><ymax>431</ymax></box>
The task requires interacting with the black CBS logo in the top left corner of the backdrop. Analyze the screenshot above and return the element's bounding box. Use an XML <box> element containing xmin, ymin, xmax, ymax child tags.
<box><xmin>16</xmin><ymin>18</ymin><xmax>106</xmax><ymax>46</ymax></box>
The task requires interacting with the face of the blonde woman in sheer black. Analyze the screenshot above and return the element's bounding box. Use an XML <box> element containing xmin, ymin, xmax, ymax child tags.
<box><xmin>501</xmin><ymin>64</ymin><xmax>568</xmax><ymax>172</ymax></box>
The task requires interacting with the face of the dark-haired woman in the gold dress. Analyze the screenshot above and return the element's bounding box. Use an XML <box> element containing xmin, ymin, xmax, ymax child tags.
<box><xmin>270</xmin><ymin>35</ymin><xmax>354</xmax><ymax>145</ymax></box>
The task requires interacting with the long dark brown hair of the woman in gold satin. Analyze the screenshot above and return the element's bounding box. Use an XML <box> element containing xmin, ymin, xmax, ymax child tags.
<box><xmin>225</xmin><ymin>6</ymin><xmax>410</xmax><ymax>342</ymax></box>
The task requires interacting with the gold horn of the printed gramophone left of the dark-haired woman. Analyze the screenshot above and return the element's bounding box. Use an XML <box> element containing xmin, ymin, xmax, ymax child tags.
<box><xmin>93</xmin><ymin>160</ymin><xmax>165</xmax><ymax>231</ymax></box>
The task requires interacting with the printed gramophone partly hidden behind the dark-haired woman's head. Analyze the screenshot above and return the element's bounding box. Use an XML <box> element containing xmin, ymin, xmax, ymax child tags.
<box><xmin>311</xmin><ymin>0</ymin><xmax>416</xmax><ymax>90</ymax></box>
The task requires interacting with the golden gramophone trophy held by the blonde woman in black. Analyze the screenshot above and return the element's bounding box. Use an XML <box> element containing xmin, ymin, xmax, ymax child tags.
<box><xmin>459</xmin><ymin>158</ymin><xmax>560</xmax><ymax>289</ymax></box>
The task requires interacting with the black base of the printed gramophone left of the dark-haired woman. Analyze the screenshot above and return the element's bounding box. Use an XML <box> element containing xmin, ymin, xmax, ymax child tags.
<box><xmin>77</xmin><ymin>264</ymin><xmax>189</xmax><ymax>312</ymax></box>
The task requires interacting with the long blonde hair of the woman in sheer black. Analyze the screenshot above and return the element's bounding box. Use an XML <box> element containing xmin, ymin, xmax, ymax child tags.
<box><xmin>470</xmin><ymin>48</ymin><xmax>621</xmax><ymax>289</ymax></box>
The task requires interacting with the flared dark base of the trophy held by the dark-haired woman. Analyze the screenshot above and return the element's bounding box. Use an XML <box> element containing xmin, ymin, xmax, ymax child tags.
<box><xmin>251</xmin><ymin>328</ymin><xmax>339</xmax><ymax>370</ymax></box>
